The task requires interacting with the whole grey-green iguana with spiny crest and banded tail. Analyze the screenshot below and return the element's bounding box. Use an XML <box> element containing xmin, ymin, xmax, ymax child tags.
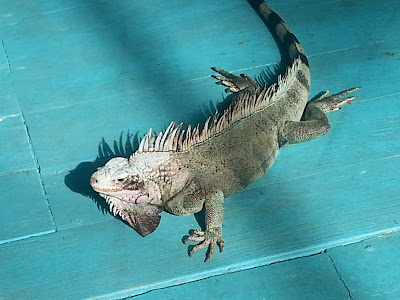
<box><xmin>90</xmin><ymin>0</ymin><xmax>359</xmax><ymax>261</ymax></box>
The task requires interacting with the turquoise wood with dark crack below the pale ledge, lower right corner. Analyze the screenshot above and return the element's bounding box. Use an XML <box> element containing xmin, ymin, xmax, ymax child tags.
<box><xmin>135</xmin><ymin>231</ymin><xmax>400</xmax><ymax>300</ymax></box>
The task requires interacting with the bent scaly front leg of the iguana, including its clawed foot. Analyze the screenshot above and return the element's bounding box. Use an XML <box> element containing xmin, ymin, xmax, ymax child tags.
<box><xmin>165</xmin><ymin>182</ymin><xmax>224</xmax><ymax>261</ymax></box>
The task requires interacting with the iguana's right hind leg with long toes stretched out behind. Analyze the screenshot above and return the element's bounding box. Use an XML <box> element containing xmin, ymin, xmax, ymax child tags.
<box><xmin>279</xmin><ymin>87</ymin><xmax>359</xmax><ymax>147</ymax></box>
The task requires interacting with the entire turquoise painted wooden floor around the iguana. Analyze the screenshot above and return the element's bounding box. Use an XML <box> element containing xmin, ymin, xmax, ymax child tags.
<box><xmin>0</xmin><ymin>0</ymin><xmax>400</xmax><ymax>300</ymax></box>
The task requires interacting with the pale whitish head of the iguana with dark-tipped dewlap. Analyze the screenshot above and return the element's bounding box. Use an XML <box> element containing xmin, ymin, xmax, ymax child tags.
<box><xmin>90</xmin><ymin>152</ymin><xmax>174</xmax><ymax>236</ymax></box>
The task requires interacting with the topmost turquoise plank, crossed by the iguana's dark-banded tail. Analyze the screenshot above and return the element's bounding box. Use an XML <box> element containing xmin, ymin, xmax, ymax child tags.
<box><xmin>5</xmin><ymin>1</ymin><xmax>399</xmax><ymax>116</ymax></box>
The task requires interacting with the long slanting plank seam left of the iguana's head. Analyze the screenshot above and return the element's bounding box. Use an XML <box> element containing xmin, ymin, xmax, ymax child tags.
<box><xmin>0</xmin><ymin>38</ymin><xmax>57</xmax><ymax>233</ymax></box>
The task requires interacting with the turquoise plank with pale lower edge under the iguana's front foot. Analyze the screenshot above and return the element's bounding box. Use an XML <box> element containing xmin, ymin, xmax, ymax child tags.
<box><xmin>0</xmin><ymin>158</ymin><xmax>400</xmax><ymax>299</ymax></box>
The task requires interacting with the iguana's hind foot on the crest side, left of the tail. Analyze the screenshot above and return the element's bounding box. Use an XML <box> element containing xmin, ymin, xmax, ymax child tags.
<box><xmin>211</xmin><ymin>67</ymin><xmax>260</xmax><ymax>94</ymax></box>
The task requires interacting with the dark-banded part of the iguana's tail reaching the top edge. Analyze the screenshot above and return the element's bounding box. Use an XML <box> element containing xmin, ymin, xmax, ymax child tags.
<box><xmin>248</xmin><ymin>0</ymin><xmax>309</xmax><ymax>66</ymax></box>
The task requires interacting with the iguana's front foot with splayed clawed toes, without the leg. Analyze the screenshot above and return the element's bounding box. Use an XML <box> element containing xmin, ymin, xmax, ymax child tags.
<box><xmin>183</xmin><ymin>227</ymin><xmax>225</xmax><ymax>262</ymax></box>
